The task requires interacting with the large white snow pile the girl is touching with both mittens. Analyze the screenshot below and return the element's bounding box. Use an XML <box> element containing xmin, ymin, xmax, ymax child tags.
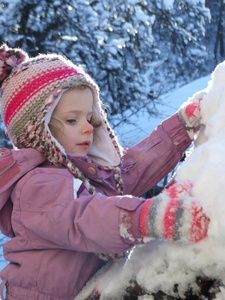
<box><xmin>76</xmin><ymin>62</ymin><xmax>225</xmax><ymax>300</ymax></box>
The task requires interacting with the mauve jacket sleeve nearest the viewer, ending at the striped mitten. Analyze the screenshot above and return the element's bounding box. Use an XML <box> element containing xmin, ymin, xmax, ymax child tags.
<box><xmin>12</xmin><ymin>168</ymin><xmax>144</xmax><ymax>253</ymax></box>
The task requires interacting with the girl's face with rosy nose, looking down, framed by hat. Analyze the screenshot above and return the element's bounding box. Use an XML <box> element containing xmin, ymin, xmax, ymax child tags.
<box><xmin>50</xmin><ymin>88</ymin><xmax>93</xmax><ymax>156</ymax></box>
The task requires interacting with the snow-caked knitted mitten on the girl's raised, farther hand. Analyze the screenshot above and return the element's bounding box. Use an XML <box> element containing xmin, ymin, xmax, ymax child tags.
<box><xmin>178</xmin><ymin>90</ymin><xmax>206</xmax><ymax>139</ymax></box>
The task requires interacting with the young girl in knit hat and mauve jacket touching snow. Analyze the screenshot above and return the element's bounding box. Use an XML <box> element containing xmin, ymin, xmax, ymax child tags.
<box><xmin>0</xmin><ymin>45</ymin><xmax>209</xmax><ymax>300</ymax></box>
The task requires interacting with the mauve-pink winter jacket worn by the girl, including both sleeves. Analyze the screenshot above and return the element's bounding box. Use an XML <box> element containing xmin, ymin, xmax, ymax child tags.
<box><xmin>0</xmin><ymin>114</ymin><xmax>191</xmax><ymax>300</ymax></box>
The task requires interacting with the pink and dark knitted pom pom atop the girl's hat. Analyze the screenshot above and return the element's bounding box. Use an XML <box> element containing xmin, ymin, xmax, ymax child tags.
<box><xmin>0</xmin><ymin>44</ymin><xmax>28</xmax><ymax>87</ymax></box>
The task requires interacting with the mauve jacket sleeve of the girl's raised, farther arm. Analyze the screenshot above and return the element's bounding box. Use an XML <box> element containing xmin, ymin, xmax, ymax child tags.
<box><xmin>121</xmin><ymin>114</ymin><xmax>192</xmax><ymax>196</ymax></box>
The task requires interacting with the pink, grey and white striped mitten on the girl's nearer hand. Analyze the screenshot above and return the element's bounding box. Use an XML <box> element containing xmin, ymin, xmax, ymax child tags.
<box><xmin>139</xmin><ymin>180</ymin><xmax>209</xmax><ymax>243</ymax></box>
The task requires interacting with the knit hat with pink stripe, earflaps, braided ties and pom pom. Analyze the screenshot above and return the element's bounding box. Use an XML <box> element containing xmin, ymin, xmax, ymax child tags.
<box><xmin>0</xmin><ymin>44</ymin><xmax>123</xmax><ymax>193</ymax></box>
